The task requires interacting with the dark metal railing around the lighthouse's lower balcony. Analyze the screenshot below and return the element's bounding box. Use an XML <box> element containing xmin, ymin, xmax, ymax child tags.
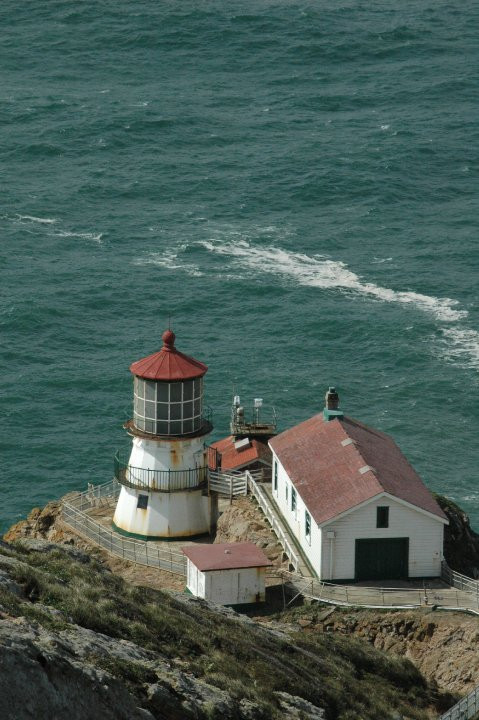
<box><xmin>114</xmin><ymin>450</ymin><xmax>208</xmax><ymax>492</ymax></box>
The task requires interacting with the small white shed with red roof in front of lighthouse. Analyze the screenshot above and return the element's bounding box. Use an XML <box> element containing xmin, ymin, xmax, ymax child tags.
<box><xmin>182</xmin><ymin>542</ymin><xmax>272</xmax><ymax>605</ymax></box>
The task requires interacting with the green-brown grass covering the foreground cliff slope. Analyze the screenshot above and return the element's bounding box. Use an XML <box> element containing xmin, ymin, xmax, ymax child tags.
<box><xmin>0</xmin><ymin>544</ymin><xmax>442</xmax><ymax>720</ymax></box>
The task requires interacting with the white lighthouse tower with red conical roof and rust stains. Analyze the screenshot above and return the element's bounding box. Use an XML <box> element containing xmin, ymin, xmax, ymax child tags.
<box><xmin>113</xmin><ymin>330</ymin><xmax>212</xmax><ymax>539</ymax></box>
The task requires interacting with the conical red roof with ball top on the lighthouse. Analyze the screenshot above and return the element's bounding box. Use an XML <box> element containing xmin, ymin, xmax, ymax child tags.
<box><xmin>130</xmin><ymin>330</ymin><xmax>208</xmax><ymax>382</ymax></box>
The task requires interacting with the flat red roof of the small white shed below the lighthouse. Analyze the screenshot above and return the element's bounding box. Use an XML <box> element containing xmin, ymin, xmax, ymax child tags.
<box><xmin>181</xmin><ymin>543</ymin><xmax>273</xmax><ymax>572</ymax></box>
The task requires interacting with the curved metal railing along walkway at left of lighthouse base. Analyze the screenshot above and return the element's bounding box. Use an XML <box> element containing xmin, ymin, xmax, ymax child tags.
<box><xmin>62</xmin><ymin>480</ymin><xmax>186</xmax><ymax>577</ymax></box>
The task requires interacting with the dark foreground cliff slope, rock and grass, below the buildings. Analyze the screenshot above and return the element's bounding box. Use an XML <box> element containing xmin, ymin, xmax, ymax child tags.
<box><xmin>0</xmin><ymin>539</ymin><xmax>446</xmax><ymax>720</ymax></box>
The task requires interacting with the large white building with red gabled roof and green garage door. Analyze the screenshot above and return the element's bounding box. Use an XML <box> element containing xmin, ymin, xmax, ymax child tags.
<box><xmin>269</xmin><ymin>388</ymin><xmax>448</xmax><ymax>581</ymax></box>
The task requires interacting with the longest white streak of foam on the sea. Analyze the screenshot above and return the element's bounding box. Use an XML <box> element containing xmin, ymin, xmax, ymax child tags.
<box><xmin>200</xmin><ymin>240</ymin><xmax>468</xmax><ymax>322</ymax></box>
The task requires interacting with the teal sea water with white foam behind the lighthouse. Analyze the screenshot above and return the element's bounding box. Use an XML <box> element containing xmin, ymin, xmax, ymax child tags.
<box><xmin>0</xmin><ymin>0</ymin><xmax>479</xmax><ymax>530</ymax></box>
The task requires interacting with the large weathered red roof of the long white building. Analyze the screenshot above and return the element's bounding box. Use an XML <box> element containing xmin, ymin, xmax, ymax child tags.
<box><xmin>270</xmin><ymin>414</ymin><xmax>446</xmax><ymax>524</ymax></box>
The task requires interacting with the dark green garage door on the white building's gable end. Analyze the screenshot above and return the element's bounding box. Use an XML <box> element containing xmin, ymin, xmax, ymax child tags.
<box><xmin>355</xmin><ymin>538</ymin><xmax>409</xmax><ymax>580</ymax></box>
